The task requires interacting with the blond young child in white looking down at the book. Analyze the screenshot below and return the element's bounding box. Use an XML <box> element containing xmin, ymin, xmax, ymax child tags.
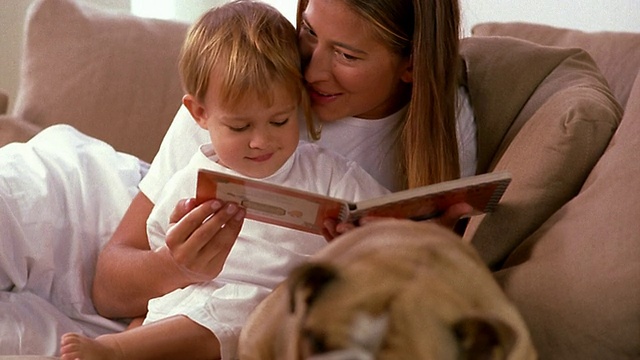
<box><xmin>61</xmin><ymin>0</ymin><xmax>388</xmax><ymax>360</ymax></box>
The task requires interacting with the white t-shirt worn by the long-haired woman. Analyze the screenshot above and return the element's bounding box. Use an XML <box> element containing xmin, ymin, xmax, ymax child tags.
<box><xmin>139</xmin><ymin>87</ymin><xmax>477</xmax><ymax>203</ymax></box>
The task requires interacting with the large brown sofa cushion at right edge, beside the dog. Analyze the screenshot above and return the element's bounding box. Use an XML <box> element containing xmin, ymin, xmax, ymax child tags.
<box><xmin>496</xmin><ymin>71</ymin><xmax>640</xmax><ymax>359</ymax></box>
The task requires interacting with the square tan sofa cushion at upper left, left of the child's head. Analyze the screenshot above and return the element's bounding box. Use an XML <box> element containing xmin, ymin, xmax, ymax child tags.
<box><xmin>14</xmin><ymin>0</ymin><xmax>188</xmax><ymax>161</ymax></box>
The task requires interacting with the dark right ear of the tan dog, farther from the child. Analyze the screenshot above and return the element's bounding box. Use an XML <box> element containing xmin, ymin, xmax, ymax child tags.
<box><xmin>453</xmin><ymin>316</ymin><xmax>517</xmax><ymax>360</ymax></box>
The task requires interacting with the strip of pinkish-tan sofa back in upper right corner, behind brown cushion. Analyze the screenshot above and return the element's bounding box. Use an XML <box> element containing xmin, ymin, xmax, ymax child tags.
<box><xmin>472</xmin><ymin>22</ymin><xmax>640</xmax><ymax>108</ymax></box>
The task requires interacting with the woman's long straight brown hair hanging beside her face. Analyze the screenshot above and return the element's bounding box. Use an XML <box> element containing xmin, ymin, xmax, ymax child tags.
<box><xmin>297</xmin><ymin>0</ymin><xmax>460</xmax><ymax>188</ymax></box>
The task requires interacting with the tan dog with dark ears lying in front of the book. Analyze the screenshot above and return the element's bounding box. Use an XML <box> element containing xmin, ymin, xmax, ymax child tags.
<box><xmin>240</xmin><ymin>220</ymin><xmax>536</xmax><ymax>360</ymax></box>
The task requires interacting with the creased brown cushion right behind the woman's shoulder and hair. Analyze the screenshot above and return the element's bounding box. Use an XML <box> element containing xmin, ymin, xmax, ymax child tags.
<box><xmin>462</xmin><ymin>37</ymin><xmax>622</xmax><ymax>268</ymax></box>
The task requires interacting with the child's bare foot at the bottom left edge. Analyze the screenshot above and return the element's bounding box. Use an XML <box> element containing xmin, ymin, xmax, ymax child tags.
<box><xmin>60</xmin><ymin>333</ymin><xmax>119</xmax><ymax>360</ymax></box>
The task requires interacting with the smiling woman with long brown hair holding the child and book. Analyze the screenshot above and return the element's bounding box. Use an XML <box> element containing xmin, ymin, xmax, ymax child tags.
<box><xmin>93</xmin><ymin>0</ymin><xmax>475</xmax><ymax>330</ymax></box>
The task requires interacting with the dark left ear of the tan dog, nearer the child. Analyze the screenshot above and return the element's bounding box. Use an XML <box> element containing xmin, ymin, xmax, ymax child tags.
<box><xmin>289</xmin><ymin>263</ymin><xmax>338</xmax><ymax>313</ymax></box>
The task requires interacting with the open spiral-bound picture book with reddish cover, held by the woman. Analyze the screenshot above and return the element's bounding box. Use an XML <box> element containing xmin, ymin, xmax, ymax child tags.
<box><xmin>196</xmin><ymin>169</ymin><xmax>511</xmax><ymax>234</ymax></box>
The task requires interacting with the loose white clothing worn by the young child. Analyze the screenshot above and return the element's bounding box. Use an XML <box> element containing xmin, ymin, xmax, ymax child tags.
<box><xmin>145</xmin><ymin>142</ymin><xmax>389</xmax><ymax>359</ymax></box>
